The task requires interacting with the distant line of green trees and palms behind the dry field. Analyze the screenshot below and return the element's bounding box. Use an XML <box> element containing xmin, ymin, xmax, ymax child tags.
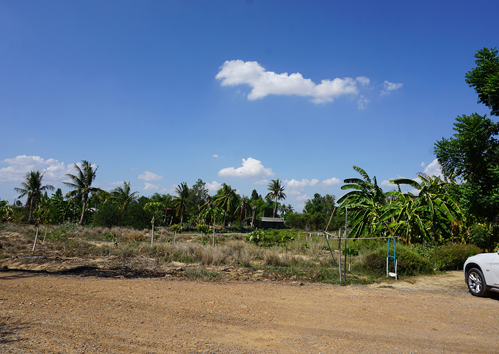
<box><xmin>0</xmin><ymin>167</ymin><xmax>344</xmax><ymax>230</ymax></box>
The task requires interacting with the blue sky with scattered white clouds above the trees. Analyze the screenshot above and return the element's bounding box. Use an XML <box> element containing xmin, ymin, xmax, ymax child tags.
<box><xmin>0</xmin><ymin>0</ymin><xmax>499</xmax><ymax>211</ymax></box>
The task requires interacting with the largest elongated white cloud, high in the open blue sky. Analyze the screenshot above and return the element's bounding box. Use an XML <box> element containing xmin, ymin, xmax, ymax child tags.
<box><xmin>216</xmin><ymin>60</ymin><xmax>370</xmax><ymax>103</ymax></box>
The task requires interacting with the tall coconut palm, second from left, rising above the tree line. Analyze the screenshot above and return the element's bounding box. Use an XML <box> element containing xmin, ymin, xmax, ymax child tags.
<box><xmin>62</xmin><ymin>160</ymin><xmax>104</xmax><ymax>225</ymax></box>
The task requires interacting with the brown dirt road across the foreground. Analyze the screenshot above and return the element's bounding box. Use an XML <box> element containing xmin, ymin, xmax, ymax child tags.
<box><xmin>0</xmin><ymin>272</ymin><xmax>499</xmax><ymax>353</ymax></box>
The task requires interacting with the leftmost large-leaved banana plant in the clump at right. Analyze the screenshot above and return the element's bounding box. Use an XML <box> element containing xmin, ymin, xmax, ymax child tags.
<box><xmin>338</xmin><ymin>166</ymin><xmax>393</xmax><ymax>238</ymax></box>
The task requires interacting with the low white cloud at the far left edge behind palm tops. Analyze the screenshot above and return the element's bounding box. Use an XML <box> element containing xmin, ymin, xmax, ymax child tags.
<box><xmin>0</xmin><ymin>155</ymin><xmax>73</xmax><ymax>185</ymax></box>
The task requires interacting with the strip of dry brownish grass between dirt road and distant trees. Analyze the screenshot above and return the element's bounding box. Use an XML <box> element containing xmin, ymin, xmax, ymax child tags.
<box><xmin>0</xmin><ymin>223</ymin><xmax>368</xmax><ymax>274</ymax></box>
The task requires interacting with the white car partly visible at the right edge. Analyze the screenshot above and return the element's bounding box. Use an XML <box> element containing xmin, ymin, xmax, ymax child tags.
<box><xmin>463</xmin><ymin>253</ymin><xmax>499</xmax><ymax>296</ymax></box>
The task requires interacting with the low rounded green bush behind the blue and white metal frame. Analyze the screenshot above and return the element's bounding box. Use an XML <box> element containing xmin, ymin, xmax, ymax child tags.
<box><xmin>364</xmin><ymin>245</ymin><xmax>433</xmax><ymax>275</ymax></box>
